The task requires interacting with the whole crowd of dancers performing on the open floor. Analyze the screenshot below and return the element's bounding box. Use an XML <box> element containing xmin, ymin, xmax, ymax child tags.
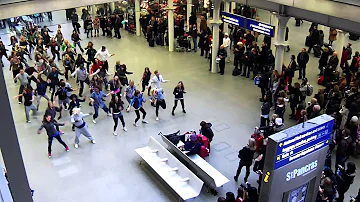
<box><xmin>4</xmin><ymin>26</ymin><xmax>186</xmax><ymax>158</ymax></box>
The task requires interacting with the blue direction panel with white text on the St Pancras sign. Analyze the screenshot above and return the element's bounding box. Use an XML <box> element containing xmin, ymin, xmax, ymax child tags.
<box><xmin>274</xmin><ymin>121</ymin><xmax>333</xmax><ymax>170</ymax></box>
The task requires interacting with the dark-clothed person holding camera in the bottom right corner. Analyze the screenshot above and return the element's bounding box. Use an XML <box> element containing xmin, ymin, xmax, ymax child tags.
<box><xmin>336</xmin><ymin>162</ymin><xmax>356</xmax><ymax>202</ymax></box>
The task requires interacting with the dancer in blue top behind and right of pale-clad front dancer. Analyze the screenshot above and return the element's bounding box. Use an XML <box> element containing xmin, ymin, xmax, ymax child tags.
<box><xmin>90</xmin><ymin>86</ymin><xmax>111</xmax><ymax>124</ymax></box>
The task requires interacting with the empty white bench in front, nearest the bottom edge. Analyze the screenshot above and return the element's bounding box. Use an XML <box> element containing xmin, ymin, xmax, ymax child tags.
<box><xmin>135</xmin><ymin>137</ymin><xmax>204</xmax><ymax>200</ymax></box>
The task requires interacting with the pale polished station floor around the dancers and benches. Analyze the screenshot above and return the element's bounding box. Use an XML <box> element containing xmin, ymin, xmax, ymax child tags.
<box><xmin>2</xmin><ymin>8</ymin><xmax>360</xmax><ymax>202</ymax></box>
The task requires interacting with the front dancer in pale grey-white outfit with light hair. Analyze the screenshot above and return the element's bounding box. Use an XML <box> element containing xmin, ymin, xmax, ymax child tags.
<box><xmin>71</xmin><ymin>108</ymin><xmax>96</xmax><ymax>149</ymax></box>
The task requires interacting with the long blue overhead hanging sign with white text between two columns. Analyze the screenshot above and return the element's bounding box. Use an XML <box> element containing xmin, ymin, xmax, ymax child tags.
<box><xmin>221</xmin><ymin>12</ymin><xmax>275</xmax><ymax>37</ymax></box>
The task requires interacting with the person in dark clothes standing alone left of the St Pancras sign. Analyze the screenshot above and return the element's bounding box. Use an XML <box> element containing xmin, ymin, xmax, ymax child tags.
<box><xmin>234</xmin><ymin>138</ymin><xmax>256</xmax><ymax>182</ymax></box>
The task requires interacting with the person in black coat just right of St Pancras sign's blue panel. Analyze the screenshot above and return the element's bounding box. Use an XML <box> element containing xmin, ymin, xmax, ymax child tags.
<box><xmin>334</xmin><ymin>128</ymin><xmax>354</xmax><ymax>170</ymax></box>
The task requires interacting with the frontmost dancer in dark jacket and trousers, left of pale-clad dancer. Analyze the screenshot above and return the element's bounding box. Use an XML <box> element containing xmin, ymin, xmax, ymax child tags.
<box><xmin>38</xmin><ymin>114</ymin><xmax>69</xmax><ymax>158</ymax></box>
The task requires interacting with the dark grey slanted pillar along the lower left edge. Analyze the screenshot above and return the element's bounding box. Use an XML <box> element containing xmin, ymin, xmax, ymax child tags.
<box><xmin>0</xmin><ymin>67</ymin><xmax>33</xmax><ymax>202</ymax></box>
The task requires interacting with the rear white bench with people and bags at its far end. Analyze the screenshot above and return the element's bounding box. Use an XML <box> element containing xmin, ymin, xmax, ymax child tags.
<box><xmin>161</xmin><ymin>135</ymin><xmax>229</xmax><ymax>195</ymax></box>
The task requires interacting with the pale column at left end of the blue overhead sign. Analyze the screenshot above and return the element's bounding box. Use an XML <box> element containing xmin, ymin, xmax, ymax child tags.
<box><xmin>209</xmin><ymin>0</ymin><xmax>222</xmax><ymax>73</ymax></box>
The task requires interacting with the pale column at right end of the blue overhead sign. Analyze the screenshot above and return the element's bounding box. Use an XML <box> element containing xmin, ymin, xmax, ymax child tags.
<box><xmin>275</xmin><ymin>15</ymin><xmax>290</xmax><ymax>73</ymax></box>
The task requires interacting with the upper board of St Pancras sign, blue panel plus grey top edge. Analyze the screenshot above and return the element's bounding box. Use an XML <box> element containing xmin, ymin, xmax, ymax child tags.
<box><xmin>274</xmin><ymin>116</ymin><xmax>334</xmax><ymax>170</ymax></box>
